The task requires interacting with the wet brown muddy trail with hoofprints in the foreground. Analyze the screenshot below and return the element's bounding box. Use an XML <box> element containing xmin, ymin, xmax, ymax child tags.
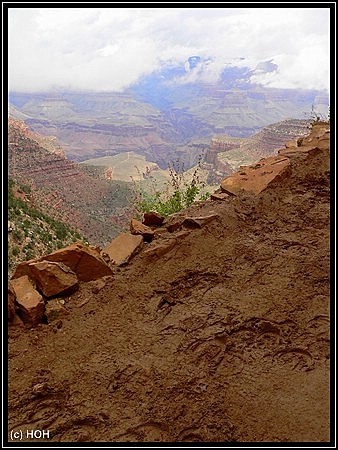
<box><xmin>8</xmin><ymin>124</ymin><xmax>330</xmax><ymax>445</ymax></box>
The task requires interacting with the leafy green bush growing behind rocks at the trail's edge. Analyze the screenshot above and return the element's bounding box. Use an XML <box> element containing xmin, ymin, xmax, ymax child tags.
<box><xmin>133</xmin><ymin>157</ymin><xmax>209</xmax><ymax>217</ymax></box>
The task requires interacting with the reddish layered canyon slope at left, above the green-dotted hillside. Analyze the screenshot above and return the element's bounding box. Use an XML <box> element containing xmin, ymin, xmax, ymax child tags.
<box><xmin>8</xmin><ymin>118</ymin><xmax>127</xmax><ymax>244</ymax></box>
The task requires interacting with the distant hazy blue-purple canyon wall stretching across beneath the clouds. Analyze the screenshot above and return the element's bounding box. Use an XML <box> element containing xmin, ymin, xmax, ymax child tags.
<box><xmin>10</xmin><ymin>80</ymin><xmax>327</xmax><ymax>169</ymax></box>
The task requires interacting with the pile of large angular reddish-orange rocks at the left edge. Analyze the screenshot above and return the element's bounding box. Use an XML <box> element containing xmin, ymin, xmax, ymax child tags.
<box><xmin>8</xmin><ymin>241</ymin><xmax>112</xmax><ymax>327</ymax></box>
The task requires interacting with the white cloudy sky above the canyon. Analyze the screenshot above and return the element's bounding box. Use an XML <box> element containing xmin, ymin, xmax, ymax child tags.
<box><xmin>9</xmin><ymin>4</ymin><xmax>329</xmax><ymax>92</ymax></box>
